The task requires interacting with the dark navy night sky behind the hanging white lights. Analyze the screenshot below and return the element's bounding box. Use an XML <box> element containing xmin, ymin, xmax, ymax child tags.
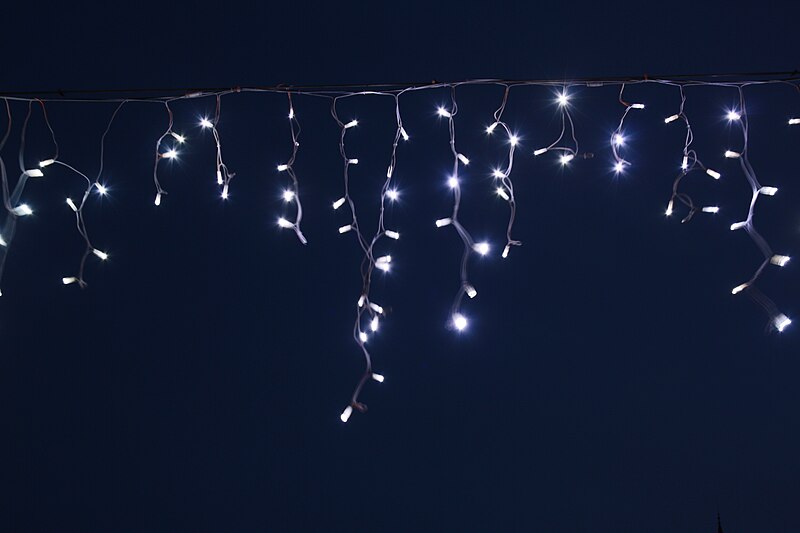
<box><xmin>0</xmin><ymin>2</ymin><xmax>800</xmax><ymax>533</ymax></box>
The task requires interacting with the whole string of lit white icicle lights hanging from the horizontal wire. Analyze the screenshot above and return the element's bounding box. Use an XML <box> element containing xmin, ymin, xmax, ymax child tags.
<box><xmin>0</xmin><ymin>77</ymin><xmax>800</xmax><ymax>421</ymax></box>
